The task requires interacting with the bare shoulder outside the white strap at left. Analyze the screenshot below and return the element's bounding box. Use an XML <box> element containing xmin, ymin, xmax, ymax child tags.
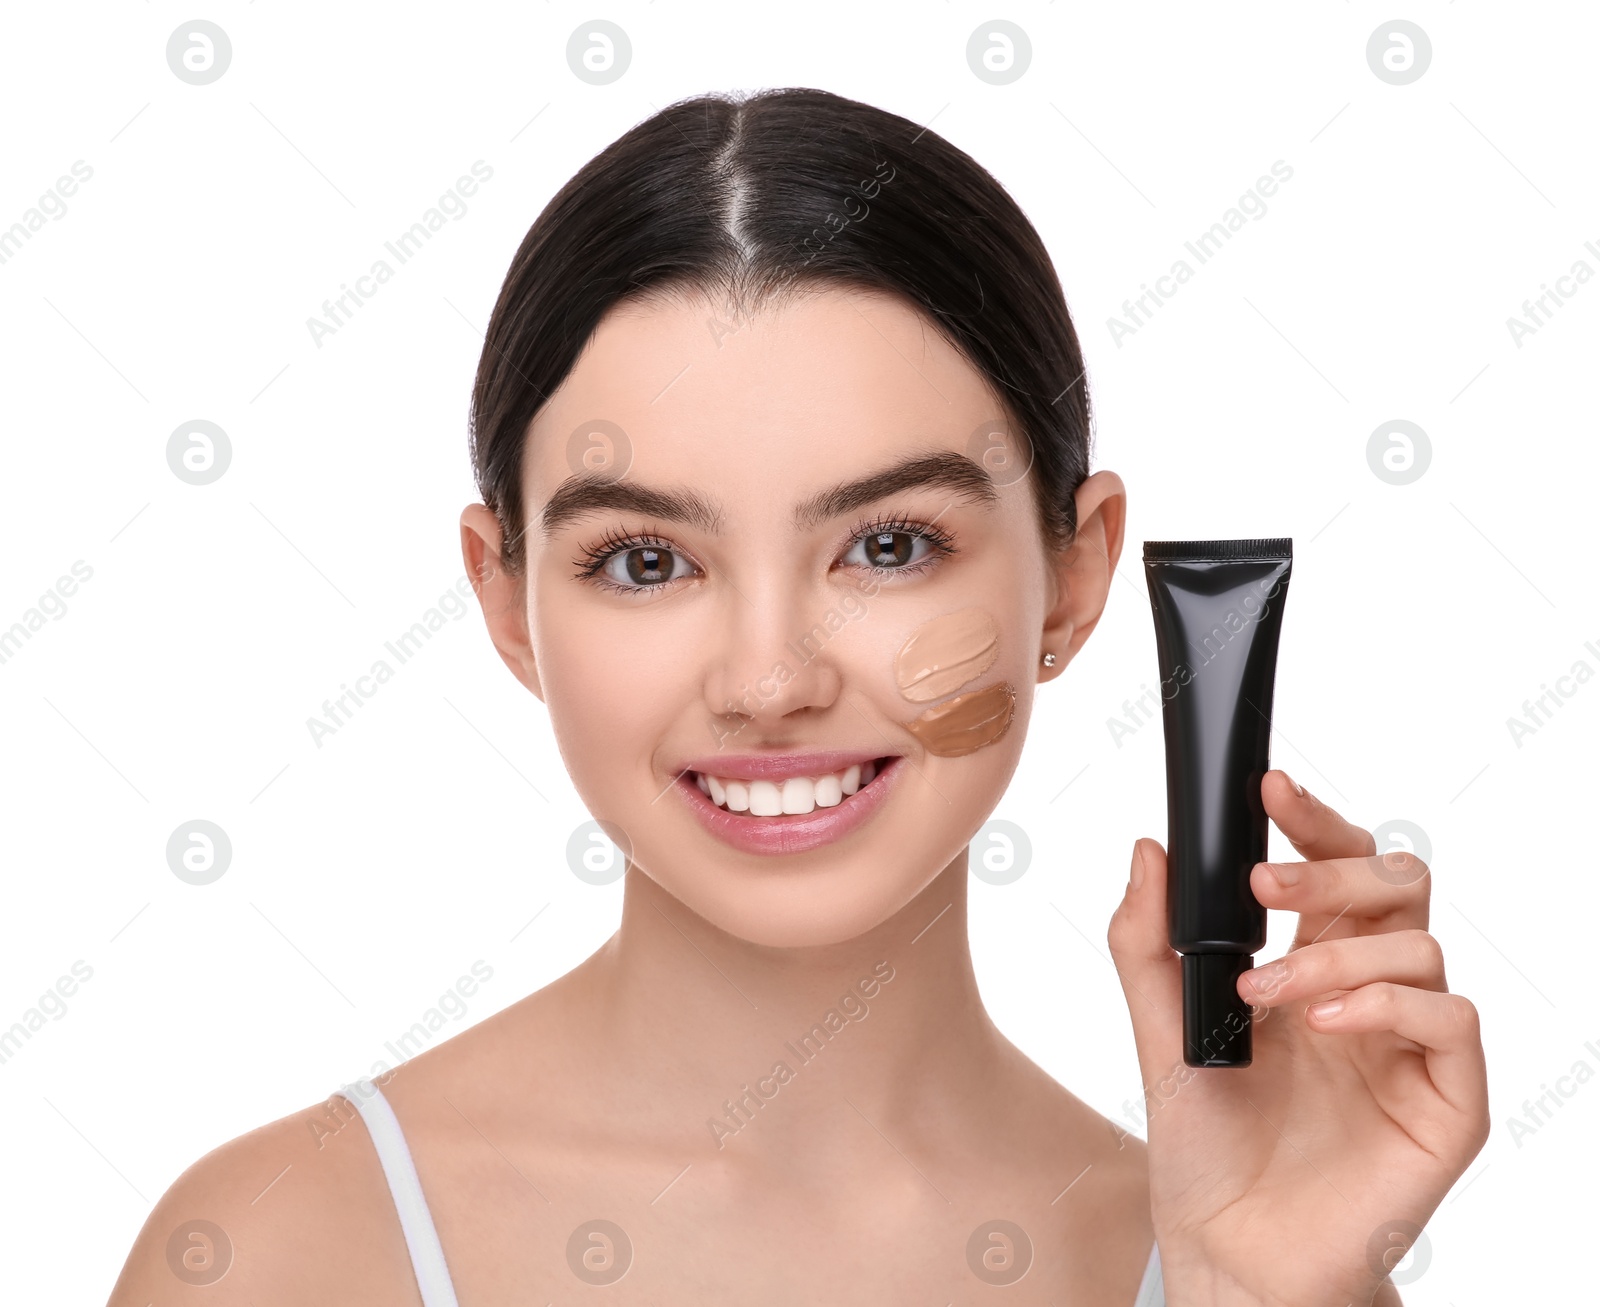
<box><xmin>109</xmin><ymin>1094</ymin><xmax>419</xmax><ymax>1307</ymax></box>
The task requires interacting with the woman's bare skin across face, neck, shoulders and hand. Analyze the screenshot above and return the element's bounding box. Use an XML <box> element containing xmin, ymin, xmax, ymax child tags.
<box><xmin>112</xmin><ymin>290</ymin><xmax>1486</xmax><ymax>1307</ymax></box>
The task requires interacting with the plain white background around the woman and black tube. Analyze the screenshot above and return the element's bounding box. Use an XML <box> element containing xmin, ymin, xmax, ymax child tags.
<box><xmin>0</xmin><ymin>0</ymin><xmax>1600</xmax><ymax>1305</ymax></box>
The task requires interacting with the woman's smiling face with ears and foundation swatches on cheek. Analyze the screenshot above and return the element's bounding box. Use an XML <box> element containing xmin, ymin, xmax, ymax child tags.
<box><xmin>462</xmin><ymin>290</ymin><xmax>1122</xmax><ymax>945</ymax></box>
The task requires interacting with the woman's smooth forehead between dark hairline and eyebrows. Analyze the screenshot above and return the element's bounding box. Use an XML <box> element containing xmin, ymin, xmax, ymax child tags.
<box><xmin>523</xmin><ymin>288</ymin><xmax>998</xmax><ymax>515</ymax></box>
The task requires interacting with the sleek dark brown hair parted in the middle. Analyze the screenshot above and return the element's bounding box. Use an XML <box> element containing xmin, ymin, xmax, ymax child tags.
<box><xmin>470</xmin><ymin>86</ymin><xmax>1090</xmax><ymax>574</ymax></box>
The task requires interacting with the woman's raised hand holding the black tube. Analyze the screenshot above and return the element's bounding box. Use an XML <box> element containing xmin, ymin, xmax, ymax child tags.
<box><xmin>1107</xmin><ymin>771</ymin><xmax>1490</xmax><ymax>1307</ymax></box>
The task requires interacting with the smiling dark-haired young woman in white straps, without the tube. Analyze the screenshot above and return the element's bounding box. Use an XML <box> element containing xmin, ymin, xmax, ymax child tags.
<box><xmin>112</xmin><ymin>90</ymin><xmax>1488</xmax><ymax>1307</ymax></box>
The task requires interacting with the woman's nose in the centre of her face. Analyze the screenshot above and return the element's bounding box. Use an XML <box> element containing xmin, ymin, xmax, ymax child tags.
<box><xmin>704</xmin><ymin>581</ymin><xmax>843</xmax><ymax>741</ymax></box>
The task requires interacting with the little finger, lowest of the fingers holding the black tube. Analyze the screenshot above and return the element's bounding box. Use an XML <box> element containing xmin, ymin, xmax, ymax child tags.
<box><xmin>1306</xmin><ymin>981</ymin><xmax>1488</xmax><ymax>1117</ymax></box>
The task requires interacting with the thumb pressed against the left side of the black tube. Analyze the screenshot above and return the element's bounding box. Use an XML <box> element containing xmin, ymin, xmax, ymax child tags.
<box><xmin>1106</xmin><ymin>838</ymin><xmax>1184</xmax><ymax>1085</ymax></box>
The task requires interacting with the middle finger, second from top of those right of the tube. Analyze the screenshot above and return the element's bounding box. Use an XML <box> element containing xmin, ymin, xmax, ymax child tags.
<box><xmin>1250</xmin><ymin>849</ymin><xmax>1432</xmax><ymax>947</ymax></box>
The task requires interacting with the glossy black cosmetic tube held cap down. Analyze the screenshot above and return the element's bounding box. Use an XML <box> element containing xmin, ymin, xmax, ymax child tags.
<box><xmin>1144</xmin><ymin>538</ymin><xmax>1293</xmax><ymax>1067</ymax></box>
